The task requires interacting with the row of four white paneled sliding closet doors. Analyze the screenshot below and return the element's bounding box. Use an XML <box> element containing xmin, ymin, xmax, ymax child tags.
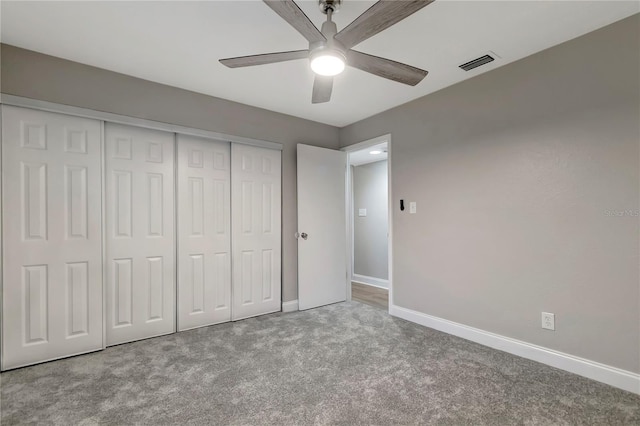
<box><xmin>0</xmin><ymin>104</ymin><xmax>281</xmax><ymax>370</ymax></box>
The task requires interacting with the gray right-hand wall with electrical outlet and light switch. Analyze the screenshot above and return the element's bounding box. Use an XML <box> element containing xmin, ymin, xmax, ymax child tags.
<box><xmin>340</xmin><ymin>15</ymin><xmax>640</xmax><ymax>373</ymax></box>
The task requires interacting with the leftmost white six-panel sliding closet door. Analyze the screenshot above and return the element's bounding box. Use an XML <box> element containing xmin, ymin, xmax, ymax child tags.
<box><xmin>2</xmin><ymin>106</ymin><xmax>103</xmax><ymax>370</ymax></box>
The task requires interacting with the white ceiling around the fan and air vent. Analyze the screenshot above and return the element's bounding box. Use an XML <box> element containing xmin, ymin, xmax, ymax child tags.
<box><xmin>1</xmin><ymin>0</ymin><xmax>640</xmax><ymax>127</ymax></box>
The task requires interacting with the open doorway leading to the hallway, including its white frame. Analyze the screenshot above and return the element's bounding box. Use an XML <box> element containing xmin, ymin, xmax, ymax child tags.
<box><xmin>343</xmin><ymin>135</ymin><xmax>391</xmax><ymax>310</ymax></box>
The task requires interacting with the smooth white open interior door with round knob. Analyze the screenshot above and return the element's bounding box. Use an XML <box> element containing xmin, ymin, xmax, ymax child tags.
<box><xmin>298</xmin><ymin>144</ymin><xmax>347</xmax><ymax>310</ymax></box>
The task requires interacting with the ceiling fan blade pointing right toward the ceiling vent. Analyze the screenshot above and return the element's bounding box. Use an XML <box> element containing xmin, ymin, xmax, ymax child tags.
<box><xmin>347</xmin><ymin>50</ymin><xmax>428</xmax><ymax>86</ymax></box>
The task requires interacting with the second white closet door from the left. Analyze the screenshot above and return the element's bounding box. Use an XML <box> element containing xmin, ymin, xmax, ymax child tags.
<box><xmin>105</xmin><ymin>123</ymin><xmax>175</xmax><ymax>345</ymax></box>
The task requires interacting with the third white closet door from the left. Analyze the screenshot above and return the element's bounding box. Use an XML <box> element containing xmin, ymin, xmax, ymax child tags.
<box><xmin>177</xmin><ymin>135</ymin><xmax>231</xmax><ymax>331</ymax></box>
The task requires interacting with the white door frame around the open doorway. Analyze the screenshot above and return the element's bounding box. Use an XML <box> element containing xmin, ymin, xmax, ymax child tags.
<box><xmin>340</xmin><ymin>133</ymin><xmax>393</xmax><ymax>312</ymax></box>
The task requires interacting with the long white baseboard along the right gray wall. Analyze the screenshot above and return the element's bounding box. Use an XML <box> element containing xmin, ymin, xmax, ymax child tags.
<box><xmin>389</xmin><ymin>305</ymin><xmax>640</xmax><ymax>394</ymax></box>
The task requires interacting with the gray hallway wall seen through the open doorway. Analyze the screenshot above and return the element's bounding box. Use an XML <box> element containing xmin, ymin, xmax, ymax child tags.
<box><xmin>352</xmin><ymin>160</ymin><xmax>389</xmax><ymax>280</ymax></box>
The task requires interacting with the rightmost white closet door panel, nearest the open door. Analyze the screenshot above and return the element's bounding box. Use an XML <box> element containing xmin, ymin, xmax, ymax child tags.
<box><xmin>231</xmin><ymin>144</ymin><xmax>281</xmax><ymax>320</ymax></box>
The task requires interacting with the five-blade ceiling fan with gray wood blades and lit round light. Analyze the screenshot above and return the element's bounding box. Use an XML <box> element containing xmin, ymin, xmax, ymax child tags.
<box><xmin>220</xmin><ymin>0</ymin><xmax>434</xmax><ymax>104</ymax></box>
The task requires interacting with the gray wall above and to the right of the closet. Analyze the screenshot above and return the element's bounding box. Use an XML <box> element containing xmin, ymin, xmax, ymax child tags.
<box><xmin>0</xmin><ymin>44</ymin><xmax>338</xmax><ymax>301</ymax></box>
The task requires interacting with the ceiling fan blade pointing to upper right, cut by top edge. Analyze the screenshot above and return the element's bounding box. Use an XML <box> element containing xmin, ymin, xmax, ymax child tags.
<box><xmin>335</xmin><ymin>0</ymin><xmax>434</xmax><ymax>49</ymax></box>
